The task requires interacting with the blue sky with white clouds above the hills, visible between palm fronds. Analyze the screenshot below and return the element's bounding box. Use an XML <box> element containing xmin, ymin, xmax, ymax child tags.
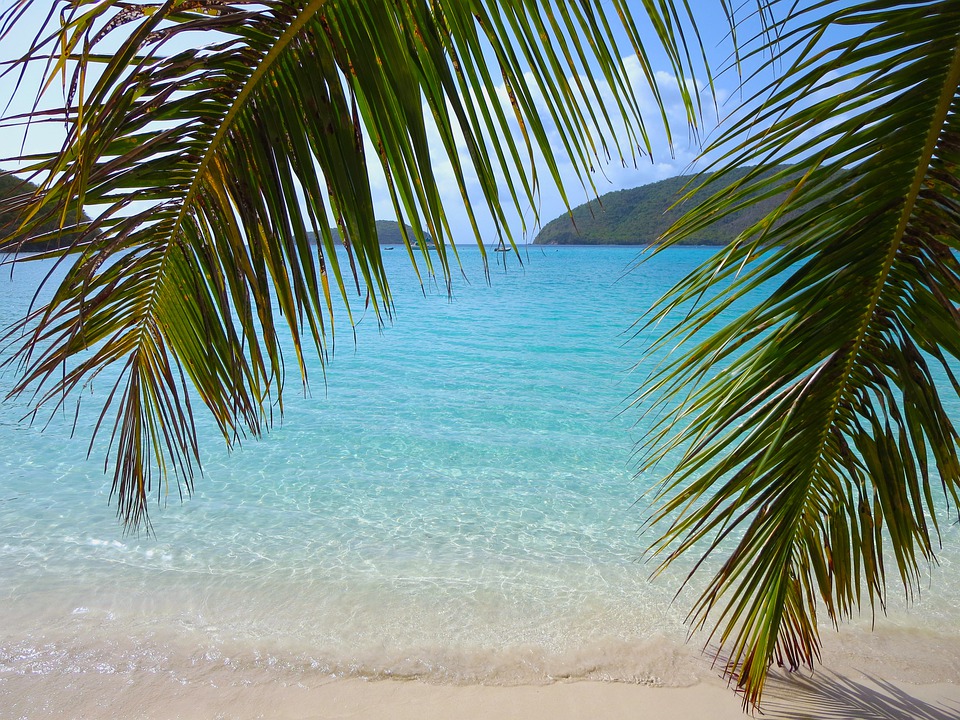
<box><xmin>0</xmin><ymin>0</ymin><xmax>788</xmax><ymax>243</ymax></box>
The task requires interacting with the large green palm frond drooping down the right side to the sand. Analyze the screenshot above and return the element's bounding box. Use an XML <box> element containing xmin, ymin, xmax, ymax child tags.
<box><xmin>641</xmin><ymin>0</ymin><xmax>960</xmax><ymax>704</ymax></box>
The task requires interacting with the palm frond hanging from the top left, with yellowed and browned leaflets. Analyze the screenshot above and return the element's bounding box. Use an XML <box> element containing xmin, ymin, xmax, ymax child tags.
<box><xmin>0</xmin><ymin>0</ymin><xmax>712</xmax><ymax>527</ymax></box>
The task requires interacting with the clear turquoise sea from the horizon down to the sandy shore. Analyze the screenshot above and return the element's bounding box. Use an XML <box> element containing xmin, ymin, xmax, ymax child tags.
<box><xmin>0</xmin><ymin>247</ymin><xmax>960</xmax><ymax>717</ymax></box>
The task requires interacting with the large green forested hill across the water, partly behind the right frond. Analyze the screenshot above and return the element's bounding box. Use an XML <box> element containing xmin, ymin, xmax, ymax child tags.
<box><xmin>534</xmin><ymin>168</ymin><xmax>779</xmax><ymax>245</ymax></box>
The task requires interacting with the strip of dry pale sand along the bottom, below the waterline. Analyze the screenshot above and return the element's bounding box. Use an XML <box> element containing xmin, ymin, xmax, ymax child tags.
<box><xmin>0</xmin><ymin>669</ymin><xmax>960</xmax><ymax>720</ymax></box>
